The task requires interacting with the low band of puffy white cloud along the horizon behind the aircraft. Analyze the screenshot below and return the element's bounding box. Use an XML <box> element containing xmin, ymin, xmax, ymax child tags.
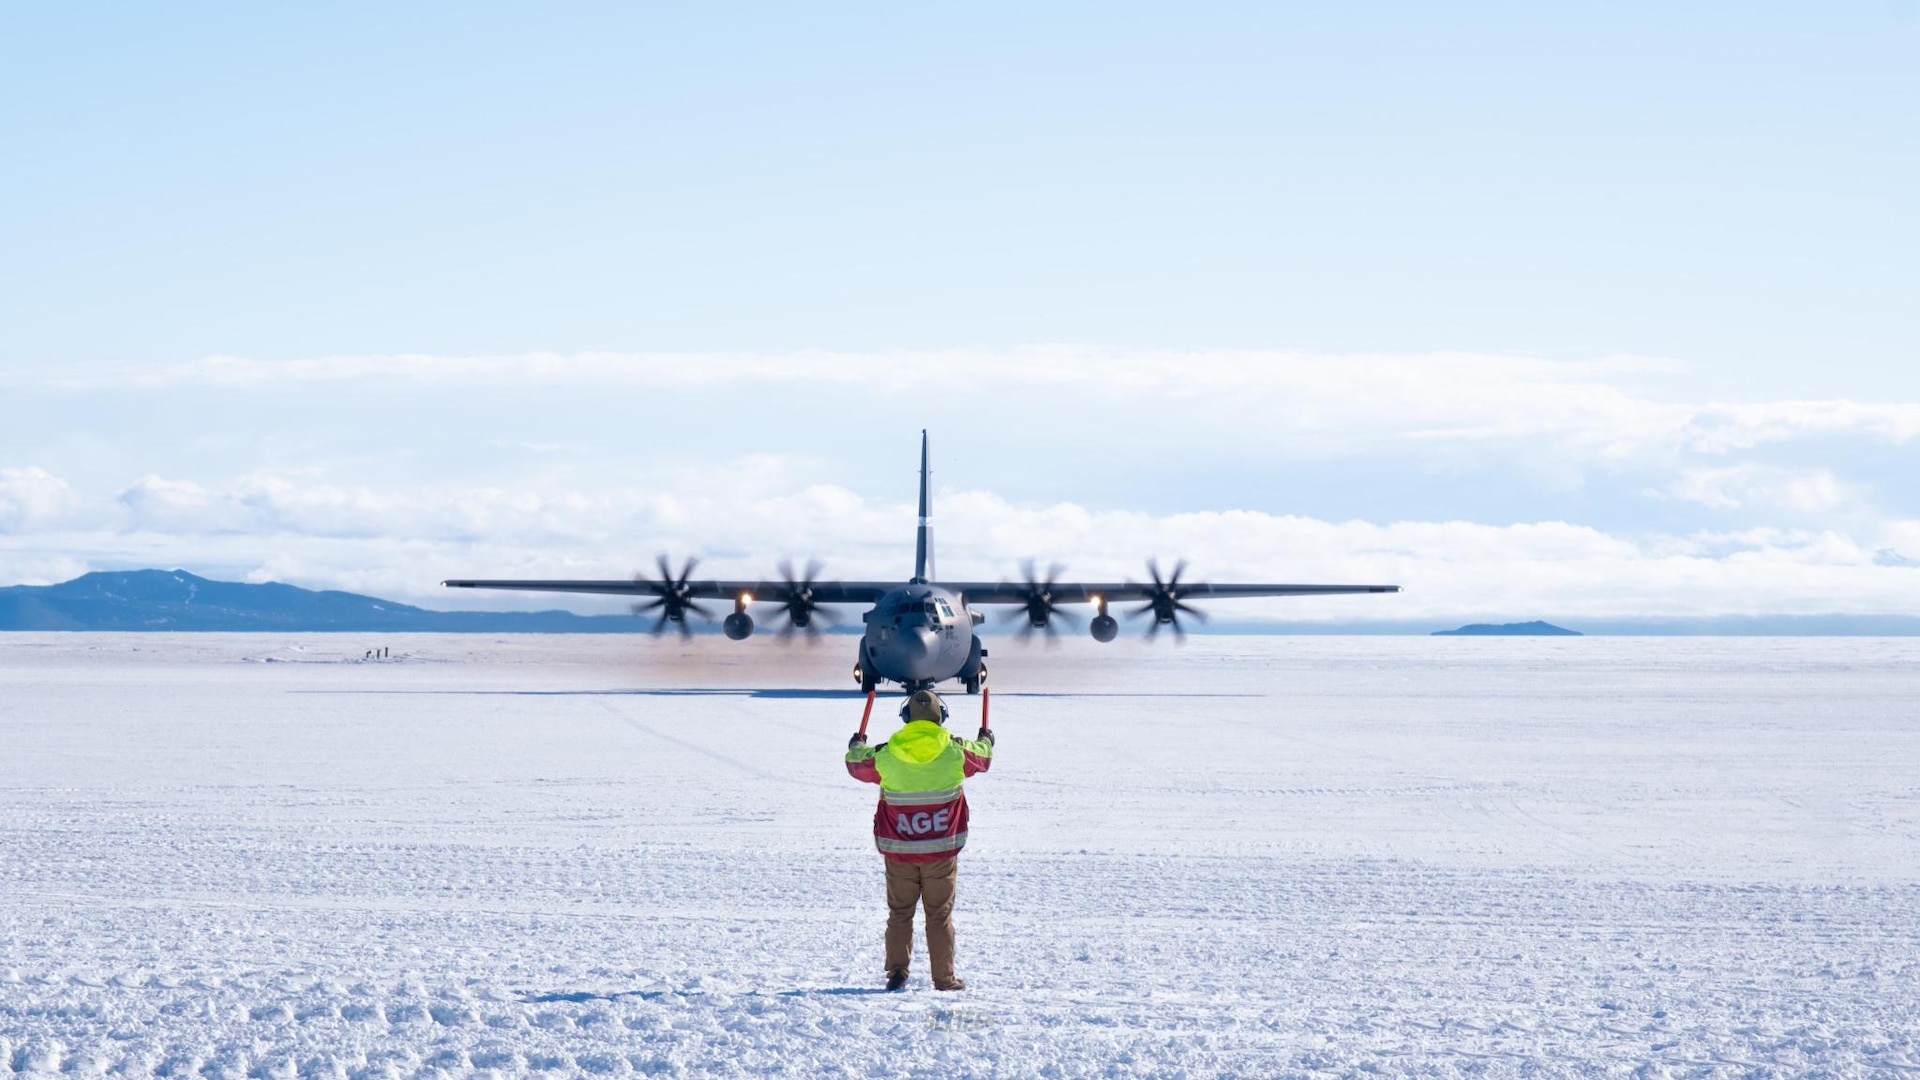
<box><xmin>0</xmin><ymin>465</ymin><xmax>1920</xmax><ymax>621</ymax></box>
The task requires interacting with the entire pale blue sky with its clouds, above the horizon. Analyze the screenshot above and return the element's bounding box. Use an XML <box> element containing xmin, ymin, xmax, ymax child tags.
<box><xmin>0</xmin><ymin>0</ymin><xmax>1920</xmax><ymax>615</ymax></box>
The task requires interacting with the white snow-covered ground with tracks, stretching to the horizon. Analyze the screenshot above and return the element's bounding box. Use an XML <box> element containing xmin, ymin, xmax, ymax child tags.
<box><xmin>0</xmin><ymin>634</ymin><xmax>1920</xmax><ymax>1076</ymax></box>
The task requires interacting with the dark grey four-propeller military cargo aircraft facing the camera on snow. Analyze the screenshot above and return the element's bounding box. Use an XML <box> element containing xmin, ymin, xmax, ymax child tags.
<box><xmin>440</xmin><ymin>432</ymin><xmax>1400</xmax><ymax>694</ymax></box>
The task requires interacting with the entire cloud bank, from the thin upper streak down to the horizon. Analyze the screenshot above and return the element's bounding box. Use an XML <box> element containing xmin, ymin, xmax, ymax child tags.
<box><xmin>0</xmin><ymin>346</ymin><xmax>1920</xmax><ymax>621</ymax></box>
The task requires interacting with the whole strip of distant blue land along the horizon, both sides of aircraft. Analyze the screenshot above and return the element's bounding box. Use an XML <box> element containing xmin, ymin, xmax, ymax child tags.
<box><xmin>0</xmin><ymin>571</ymin><xmax>1920</xmax><ymax>638</ymax></box>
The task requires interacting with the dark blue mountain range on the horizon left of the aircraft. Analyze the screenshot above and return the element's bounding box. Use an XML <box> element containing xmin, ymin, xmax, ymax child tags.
<box><xmin>0</xmin><ymin>571</ymin><xmax>647</xmax><ymax>634</ymax></box>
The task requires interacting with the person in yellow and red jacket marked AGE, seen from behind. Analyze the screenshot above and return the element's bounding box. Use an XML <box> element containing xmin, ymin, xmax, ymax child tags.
<box><xmin>847</xmin><ymin>690</ymin><xmax>993</xmax><ymax>990</ymax></box>
